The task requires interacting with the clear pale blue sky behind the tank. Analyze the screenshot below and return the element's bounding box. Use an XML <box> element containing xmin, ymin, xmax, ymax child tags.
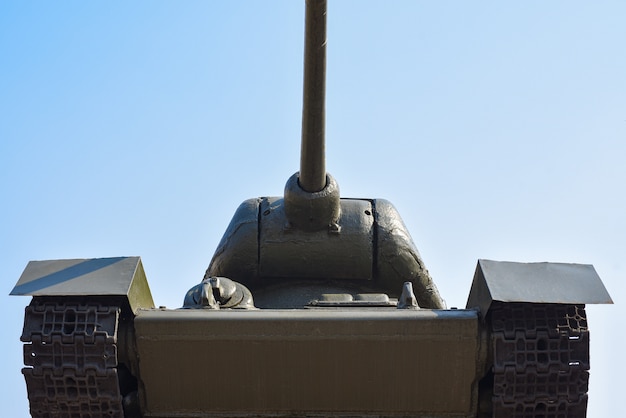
<box><xmin>0</xmin><ymin>0</ymin><xmax>626</xmax><ymax>418</ymax></box>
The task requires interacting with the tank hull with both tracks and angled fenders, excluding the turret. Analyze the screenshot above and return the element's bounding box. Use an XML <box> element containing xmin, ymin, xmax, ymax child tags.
<box><xmin>13</xmin><ymin>257</ymin><xmax>612</xmax><ymax>418</ymax></box>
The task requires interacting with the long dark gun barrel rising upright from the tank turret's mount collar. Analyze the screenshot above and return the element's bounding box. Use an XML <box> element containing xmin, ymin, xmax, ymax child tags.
<box><xmin>298</xmin><ymin>0</ymin><xmax>326</xmax><ymax>193</ymax></box>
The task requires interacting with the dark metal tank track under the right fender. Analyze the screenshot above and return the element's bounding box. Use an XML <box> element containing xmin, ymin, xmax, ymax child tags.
<box><xmin>490</xmin><ymin>302</ymin><xmax>589</xmax><ymax>418</ymax></box>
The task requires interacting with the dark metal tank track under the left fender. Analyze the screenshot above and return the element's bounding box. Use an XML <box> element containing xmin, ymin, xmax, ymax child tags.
<box><xmin>21</xmin><ymin>298</ymin><xmax>124</xmax><ymax>418</ymax></box>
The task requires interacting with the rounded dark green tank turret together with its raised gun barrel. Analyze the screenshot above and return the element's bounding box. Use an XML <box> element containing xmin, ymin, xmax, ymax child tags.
<box><xmin>206</xmin><ymin>1</ymin><xmax>444</xmax><ymax>309</ymax></box>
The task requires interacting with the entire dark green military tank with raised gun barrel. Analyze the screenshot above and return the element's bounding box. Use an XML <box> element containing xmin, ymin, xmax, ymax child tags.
<box><xmin>11</xmin><ymin>0</ymin><xmax>612</xmax><ymax>418</ymax></box>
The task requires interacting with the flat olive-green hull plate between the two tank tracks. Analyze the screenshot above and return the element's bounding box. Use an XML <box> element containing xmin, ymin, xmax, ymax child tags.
<box><xmin>135</xmin><ymin>308</ymin><xmax>478</xmax><ymax>417</ymax></box>
